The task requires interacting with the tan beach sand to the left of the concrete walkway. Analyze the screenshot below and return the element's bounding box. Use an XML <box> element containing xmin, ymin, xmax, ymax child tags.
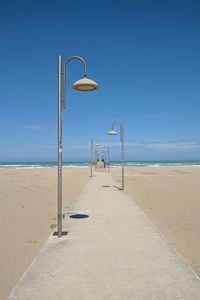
<box><xmin>0</xmin><ymin>168</ymin><xmax>89</xmax><ymax>300</ymax></box>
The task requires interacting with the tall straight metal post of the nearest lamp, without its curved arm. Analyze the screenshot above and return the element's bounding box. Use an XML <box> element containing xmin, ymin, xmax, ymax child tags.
<box><xmin>58</xmin><ymin>56</ymin><xmax>62</xmax><ymax>237</ymax></box>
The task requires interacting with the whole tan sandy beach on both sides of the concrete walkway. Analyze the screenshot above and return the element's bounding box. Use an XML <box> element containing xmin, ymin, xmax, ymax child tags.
<box><xmin>0</xmin><ymin>167</ymin><xmax>200</xmax><ymax>300</ymax></box>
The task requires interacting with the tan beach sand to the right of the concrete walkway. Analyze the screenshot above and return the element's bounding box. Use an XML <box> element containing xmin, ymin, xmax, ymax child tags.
<box><xmin>111</xmin><ymin>167</ymin><xmax>200</xmax><ymax>276</ymax></box>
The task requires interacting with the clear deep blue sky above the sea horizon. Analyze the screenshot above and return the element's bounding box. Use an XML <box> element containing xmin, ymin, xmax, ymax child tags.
<box><xmin>0</xmin><ymin>0</ymin><xmax>200</xmax><ymax>161</ymax></box>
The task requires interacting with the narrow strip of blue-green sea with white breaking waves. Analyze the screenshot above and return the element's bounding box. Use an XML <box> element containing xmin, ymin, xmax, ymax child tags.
<box><xmin>0</xmin><ymin>160</ymin><xmax>200</xmax><ymax>169</ymax></box>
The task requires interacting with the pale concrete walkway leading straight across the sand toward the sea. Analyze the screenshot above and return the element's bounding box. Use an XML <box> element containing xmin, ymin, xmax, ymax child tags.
<box><xmin>8</xmin><ymin>172</ymin><xmax>200</xmax><ymax>300</ymax></box>
